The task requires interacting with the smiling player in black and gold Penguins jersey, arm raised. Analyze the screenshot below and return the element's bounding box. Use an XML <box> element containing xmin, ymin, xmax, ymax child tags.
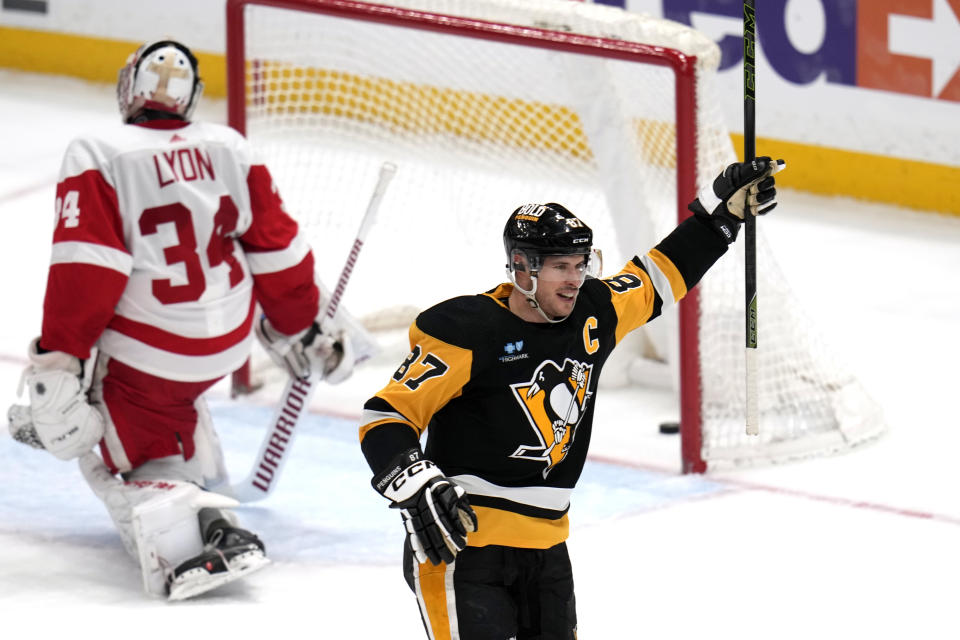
<box><xmin>360</xmin><ymin>157</ymin><xmax>785</xmax><ymax>640</ymax></box>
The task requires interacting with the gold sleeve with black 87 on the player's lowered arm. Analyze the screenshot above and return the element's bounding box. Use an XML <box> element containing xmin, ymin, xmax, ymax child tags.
<box><xmin>360</xmin><ymin>319</ymin><xmax>473</xmax><ymax>473</ymax></box>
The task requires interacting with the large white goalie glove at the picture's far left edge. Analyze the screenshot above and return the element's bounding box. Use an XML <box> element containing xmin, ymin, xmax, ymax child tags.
<box><xmin>7</xmin><ymin>338</ymin><xmax>103</xmax><ymax>460</ymax></box>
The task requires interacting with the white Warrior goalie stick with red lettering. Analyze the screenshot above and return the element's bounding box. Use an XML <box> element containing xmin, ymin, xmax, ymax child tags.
<box><xmin>225</xmin><ymin>162</ymin><xmax>397</xmax><ymax>502</ymax></box>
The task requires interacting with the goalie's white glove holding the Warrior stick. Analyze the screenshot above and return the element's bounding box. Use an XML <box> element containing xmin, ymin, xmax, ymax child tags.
<box><xmin>256</xmin><ymin>316</ymin><xmax>355</xmax><ymax>384</ymax></box>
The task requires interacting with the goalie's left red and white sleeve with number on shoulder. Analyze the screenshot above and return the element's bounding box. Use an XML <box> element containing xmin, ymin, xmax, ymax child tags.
<box><xmin>40</xmin><ymin>139</ymin><xmax>133</xmax><ymax>359</ymax></box>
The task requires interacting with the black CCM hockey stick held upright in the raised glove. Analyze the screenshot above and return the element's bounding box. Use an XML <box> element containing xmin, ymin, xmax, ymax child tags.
<box><xmin>743</xmin><ymin>0</ymin><xmax>760</xmax><ymax>436</ymax></box>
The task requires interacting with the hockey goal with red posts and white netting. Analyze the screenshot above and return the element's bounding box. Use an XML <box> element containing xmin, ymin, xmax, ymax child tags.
<box><xmin>227</xmin><ymin>0</ymin><xmax>884</xmax><ymax>471</ymax></box>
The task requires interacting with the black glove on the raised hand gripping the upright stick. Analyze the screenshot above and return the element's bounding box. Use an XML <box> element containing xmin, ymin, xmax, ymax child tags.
<box><xmin>687</xmin><ymin>156</ymin><xmax>787</xmax><ymax>244</ymax></box>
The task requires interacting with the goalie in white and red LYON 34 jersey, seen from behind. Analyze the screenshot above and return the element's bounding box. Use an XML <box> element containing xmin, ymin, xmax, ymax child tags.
<box><xmin>9</xmin><ymin>40</ymin><xmax>353</xmax><ymax>600</ymax></box>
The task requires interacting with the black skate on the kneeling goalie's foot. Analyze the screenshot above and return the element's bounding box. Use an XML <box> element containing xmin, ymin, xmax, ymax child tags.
<box><xmin>167</xmin><ymin>520</ymin><xmax>270</xmax><ymax>600</ymax></box>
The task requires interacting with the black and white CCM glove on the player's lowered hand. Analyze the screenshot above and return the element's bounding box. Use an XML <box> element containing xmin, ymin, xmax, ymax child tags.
<box><xmin>371</xmin><ymin>448</ymin><xmax>477</xmax><ymax>565</ymax></box>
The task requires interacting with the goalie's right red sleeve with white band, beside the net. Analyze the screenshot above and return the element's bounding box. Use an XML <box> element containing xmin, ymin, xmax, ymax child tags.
<box><xmin>240</xmin><ymin>164</ymin><xmax>320</xmax><ymax>335</ymax></box>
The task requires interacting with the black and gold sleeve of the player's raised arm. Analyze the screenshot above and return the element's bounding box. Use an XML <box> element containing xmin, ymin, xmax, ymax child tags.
<box><xmin>602</xmin><ymin>216</ymin><xmax>727</xmax><ymax>343</ymax></box>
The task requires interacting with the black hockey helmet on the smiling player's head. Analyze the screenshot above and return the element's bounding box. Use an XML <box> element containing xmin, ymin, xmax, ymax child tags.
<box><xmin>503</xmin><ymin>202</ymin><xmax>593</xmax><ymax>272</ymax></box>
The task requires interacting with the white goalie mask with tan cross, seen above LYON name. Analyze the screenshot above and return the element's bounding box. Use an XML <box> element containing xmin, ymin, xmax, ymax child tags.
<box><xmin>117</xmin><ymin>40</ymin><xmax>203</xmax><ymax>122</ymax></box>
